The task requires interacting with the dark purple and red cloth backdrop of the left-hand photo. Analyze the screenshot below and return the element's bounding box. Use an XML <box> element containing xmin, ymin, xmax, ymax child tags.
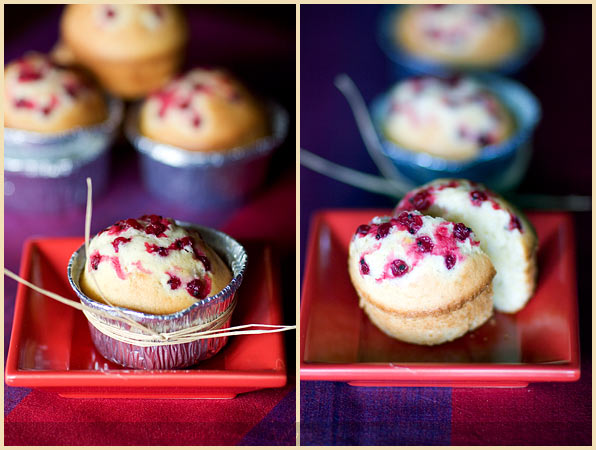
<box><xmin>4</xmin><ymin>5</ymin><xmax>296</xmax><ymax>445</ymax></box>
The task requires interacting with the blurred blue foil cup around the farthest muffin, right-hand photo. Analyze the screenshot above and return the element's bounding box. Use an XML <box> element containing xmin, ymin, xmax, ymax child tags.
<box><xmin>377</xmin><ymin>5</ymin><xmax>544</xmax><ymax>78</ymax></box>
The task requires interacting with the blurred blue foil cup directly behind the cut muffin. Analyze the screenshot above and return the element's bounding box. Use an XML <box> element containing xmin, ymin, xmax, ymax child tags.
<box><xmin>370</xmin><ymin>74</ymin><xmax>541</xmax><ymax>191</ymax></box>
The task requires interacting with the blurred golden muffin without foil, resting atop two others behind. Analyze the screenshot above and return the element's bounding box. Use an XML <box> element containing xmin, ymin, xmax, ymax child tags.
<box><xmin>61</xmin><ymin>4</ymin><xmax>188</xmax><ymax>99</ymax></box>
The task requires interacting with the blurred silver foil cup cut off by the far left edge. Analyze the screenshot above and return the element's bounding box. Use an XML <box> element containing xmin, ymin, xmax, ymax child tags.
<box><xmin>4</xmin><ymin>98</ymin><xmax>123</xmax><ymax>213</ymax></box>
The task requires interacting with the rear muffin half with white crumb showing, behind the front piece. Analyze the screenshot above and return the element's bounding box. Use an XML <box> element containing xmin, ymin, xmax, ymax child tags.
<box><xmin>395</xmin><ymin>179</ymin><xmax>538</xmax><ymax>313</ymax></box>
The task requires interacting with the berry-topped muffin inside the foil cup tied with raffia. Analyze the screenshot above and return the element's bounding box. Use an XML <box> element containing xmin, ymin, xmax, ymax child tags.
<box><xmin>80</xmin><ymin>215</ymin><xmax>232</xmax><ymax>314</ymax></box>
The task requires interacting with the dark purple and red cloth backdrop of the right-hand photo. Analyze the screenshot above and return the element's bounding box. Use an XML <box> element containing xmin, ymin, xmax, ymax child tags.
<box><xmin>300</xmin><ymin>5</ymin><xmax>592</xmax><ymax>445</ymax></box>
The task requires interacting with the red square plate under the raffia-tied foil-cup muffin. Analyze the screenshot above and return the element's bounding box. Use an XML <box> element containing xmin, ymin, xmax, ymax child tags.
<box><xmin>6</xmin><ymin>238</ymin><xmax>286</xmax><ymax>398</ymax></box>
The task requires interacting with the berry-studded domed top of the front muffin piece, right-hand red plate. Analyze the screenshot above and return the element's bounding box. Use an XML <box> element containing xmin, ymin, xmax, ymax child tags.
<box><xmin>349</xmin><ymin>211</ymin><xmax>494</xmax><ymax>314</ymax></box>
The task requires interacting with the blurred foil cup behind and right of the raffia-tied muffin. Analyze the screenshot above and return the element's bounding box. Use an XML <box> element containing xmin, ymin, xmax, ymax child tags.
<box><xmin>125</xmin><ymin>102</ymin><xmax>289</xmax><ymax>210</ymax></box>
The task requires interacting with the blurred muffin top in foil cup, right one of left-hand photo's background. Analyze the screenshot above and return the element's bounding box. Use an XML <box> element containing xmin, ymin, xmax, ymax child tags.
<box><xmin>139</xmin><ymin>68</ymin><xmax>268</xmax><ymax>152</ymax></box>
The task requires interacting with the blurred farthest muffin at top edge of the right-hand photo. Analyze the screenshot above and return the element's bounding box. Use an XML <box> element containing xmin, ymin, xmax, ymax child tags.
<box><xmin>395</xmin><ymin>5</ymin><xmax>520</xmax><ymax>67</ymax></box>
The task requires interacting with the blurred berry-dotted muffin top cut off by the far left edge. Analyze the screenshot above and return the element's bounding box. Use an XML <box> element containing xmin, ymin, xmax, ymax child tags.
<box><xmin>4</xmin><ymin>53</ymin><xmax>107</xmax><ymax>132</ymax></box>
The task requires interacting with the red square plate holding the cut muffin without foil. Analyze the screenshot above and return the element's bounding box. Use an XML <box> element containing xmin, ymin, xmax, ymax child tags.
<box><xmin>300</xmin><ymin>210</ymin><xmax>580</xmax><ymax>387</ymax></box>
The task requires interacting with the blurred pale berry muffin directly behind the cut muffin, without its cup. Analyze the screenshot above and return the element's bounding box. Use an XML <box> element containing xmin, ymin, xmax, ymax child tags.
<box><xmin>384</xmin><ymin>77</ymin><xmax>513</xmax><ymax>160</ymax></box>
